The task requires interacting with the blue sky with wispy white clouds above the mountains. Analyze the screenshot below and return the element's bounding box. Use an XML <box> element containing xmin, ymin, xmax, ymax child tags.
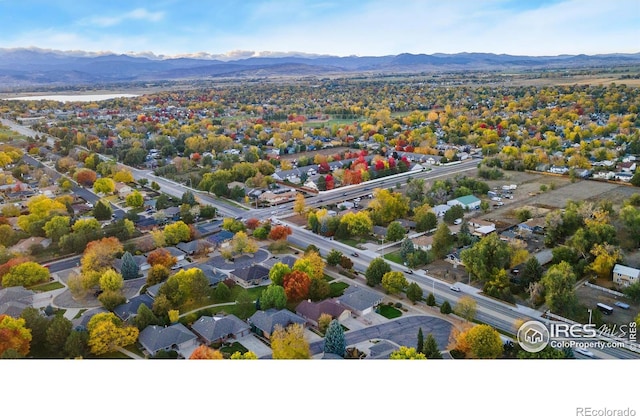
<box><xmin>0</xmin><ymin>0</ymin><xmax>640</xmax><ymax>59</ymax></box>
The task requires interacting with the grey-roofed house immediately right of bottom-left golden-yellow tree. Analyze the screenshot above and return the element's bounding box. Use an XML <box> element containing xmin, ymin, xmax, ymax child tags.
<box><xmin>138</xmin><ymin>323</ymin><xmax>198</xmax><ymax>358</ymax></box>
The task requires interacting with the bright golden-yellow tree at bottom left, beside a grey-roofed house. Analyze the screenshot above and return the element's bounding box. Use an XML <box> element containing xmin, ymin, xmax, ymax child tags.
<box><xmin>87</xmin><ymin>312</ymin><xmax>139</xmax><ymax>355</ymax></box>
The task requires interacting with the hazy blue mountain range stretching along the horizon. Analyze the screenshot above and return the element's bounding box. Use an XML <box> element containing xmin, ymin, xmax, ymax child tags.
<box><xmin>0</xmin><ymin>48</ymin><xmax>640</xmax><ymax>89</ymax></box>
